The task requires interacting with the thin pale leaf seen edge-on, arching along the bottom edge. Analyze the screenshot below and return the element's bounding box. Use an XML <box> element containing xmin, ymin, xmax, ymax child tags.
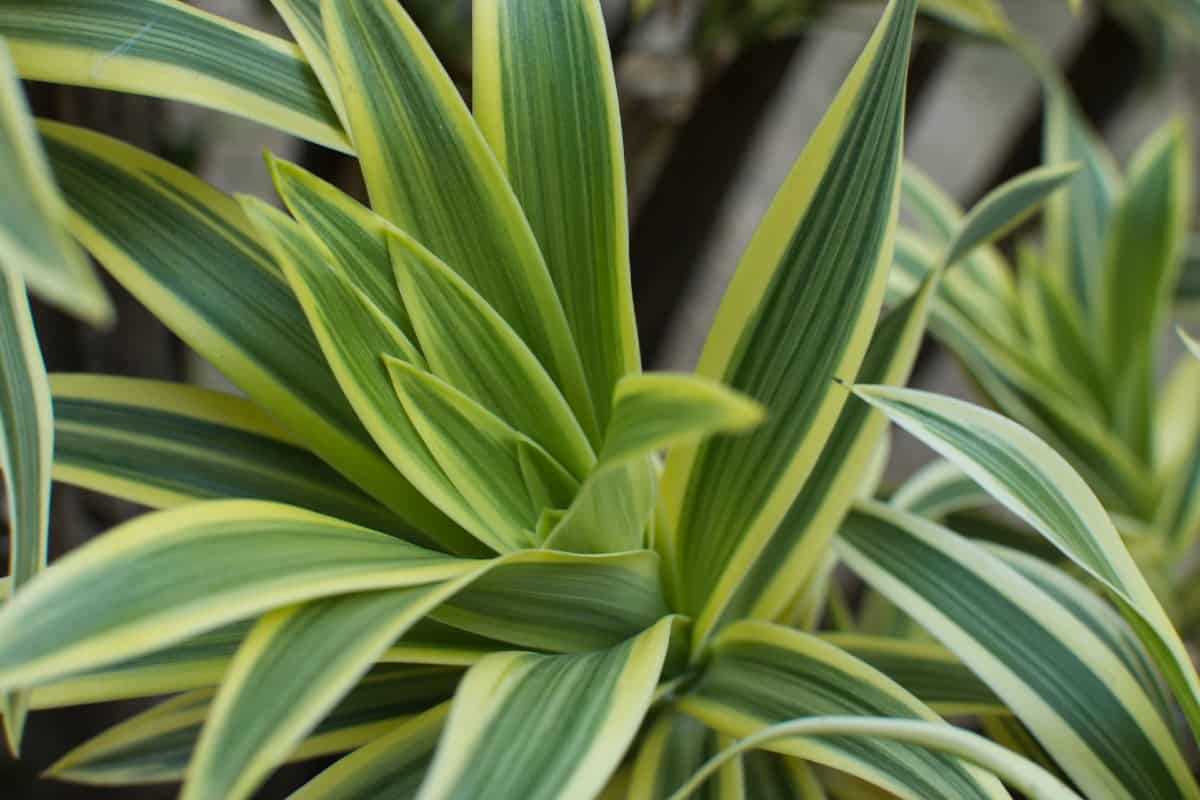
<box><xmin>670</xmin><ymin>716</ymin><xmax>1081</xmax><ymax>800</ymax></box>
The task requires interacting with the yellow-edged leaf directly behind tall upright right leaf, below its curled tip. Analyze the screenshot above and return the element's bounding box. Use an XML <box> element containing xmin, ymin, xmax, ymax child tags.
<box><xmin>701</xmin><ymin>273</ymin><xmax>938</xmax><ymax>624</ymax></box>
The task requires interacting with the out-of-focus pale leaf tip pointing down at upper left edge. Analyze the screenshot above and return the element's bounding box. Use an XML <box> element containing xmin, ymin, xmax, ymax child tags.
<box><xmin>0</xmin><ymin>39</ymin><xmax>113</xmax><ymax>323</ymax></box>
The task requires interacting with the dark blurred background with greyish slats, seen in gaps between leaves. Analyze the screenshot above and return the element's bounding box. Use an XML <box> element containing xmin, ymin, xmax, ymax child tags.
<box><xmin>7</xmin><ymin>0</ymin><xmax>1200</xmax><ymax>800</ymax></box>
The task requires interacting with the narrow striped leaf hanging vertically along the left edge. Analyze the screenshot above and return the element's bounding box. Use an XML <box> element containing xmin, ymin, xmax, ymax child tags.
<box><xmin>0</xmin><ymin>266</ymin><xmax>54</xmax><ymax>753</ymax></box>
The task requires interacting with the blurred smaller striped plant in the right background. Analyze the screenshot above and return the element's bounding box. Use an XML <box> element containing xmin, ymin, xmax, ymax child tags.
<box><xmin>892</xmin><ymin>71</ymin><xmax>1200</xmax><ymax>633</ymax></box>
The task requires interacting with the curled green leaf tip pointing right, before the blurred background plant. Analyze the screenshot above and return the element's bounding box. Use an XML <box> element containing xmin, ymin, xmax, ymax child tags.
<box><xmin>944</xmin><ymin>163</ymin><xmax>1079</xmax><ymax>265</ymax></box>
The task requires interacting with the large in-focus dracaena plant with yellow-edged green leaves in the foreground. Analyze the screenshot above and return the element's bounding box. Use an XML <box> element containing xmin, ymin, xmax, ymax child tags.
<box><xmin>0</xmin><ymin>0</ymin><xmax>1200</xmax><ymax>800</ymax></box>
